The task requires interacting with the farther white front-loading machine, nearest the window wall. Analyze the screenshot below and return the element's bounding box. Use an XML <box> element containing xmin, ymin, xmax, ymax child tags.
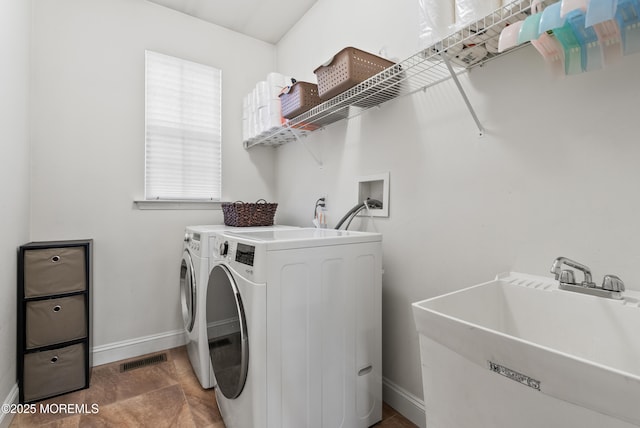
<box><xmin>180</xmin><ymin>225</ymin><xmax>291</xmax><ymax>388</ymax></box>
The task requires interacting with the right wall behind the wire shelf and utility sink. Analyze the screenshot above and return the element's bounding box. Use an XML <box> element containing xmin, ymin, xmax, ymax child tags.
<box><xmin>277</xmin><ymin>0</ymin><xmax>640</xmax><ymax>418</ymax></box>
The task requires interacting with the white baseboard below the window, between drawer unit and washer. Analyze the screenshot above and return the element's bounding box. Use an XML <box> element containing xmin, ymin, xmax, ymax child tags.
<box><xmin>92</xmin><ymin>330</ymin><xmax>187</xmax><ymax>366</ymax></box>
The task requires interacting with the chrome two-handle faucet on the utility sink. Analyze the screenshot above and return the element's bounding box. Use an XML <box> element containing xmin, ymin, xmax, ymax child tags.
<box><xmin>551</xmin><ymin>257</ymin><xmax>624</xmax><ymax>299</ymax></box>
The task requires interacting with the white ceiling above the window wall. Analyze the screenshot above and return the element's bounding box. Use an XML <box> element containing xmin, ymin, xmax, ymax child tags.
<box><xmin>149</xmin><ymin>0</ymin><xmax>317</xmax><ymax>44</ymax></box>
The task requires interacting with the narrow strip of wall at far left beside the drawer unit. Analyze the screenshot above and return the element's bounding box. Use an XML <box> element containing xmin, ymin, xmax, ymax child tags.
<box><xmin>0</xmin><ymin>0</ymin><xmax>31</xmax><ymax>425</ymax></box>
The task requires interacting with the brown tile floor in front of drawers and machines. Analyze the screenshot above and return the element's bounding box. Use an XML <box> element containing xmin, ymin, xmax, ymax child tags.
<box><xmin>10</xmin><ymin>347</ymin><xmax>415</xmax><ymax>428</ymax></box>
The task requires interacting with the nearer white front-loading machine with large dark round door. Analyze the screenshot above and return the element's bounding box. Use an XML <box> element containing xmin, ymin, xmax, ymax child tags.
<box><xmin>207</xmin><ymin>229</ymin><xmax>382</xmax><ymax>428</ymax></box>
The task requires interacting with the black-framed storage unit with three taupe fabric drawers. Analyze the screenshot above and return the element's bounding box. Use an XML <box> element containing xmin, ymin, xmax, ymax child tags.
<box><xmin>17</xmin><ymin>240</ymin><xmax>92</xmax><ymax>403</ymax></box>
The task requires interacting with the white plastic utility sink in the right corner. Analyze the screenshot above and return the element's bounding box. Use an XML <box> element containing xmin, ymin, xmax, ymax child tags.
<box><xmin>412</xmin><ymin>273</ymin><xmax>640</xmax><ymax>427</ymax></box>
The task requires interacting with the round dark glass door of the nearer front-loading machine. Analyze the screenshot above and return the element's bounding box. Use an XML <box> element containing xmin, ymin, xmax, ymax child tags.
<box><xmin>207</xmin><ymin>265</ymin><xmax>249</xmax><ymax>399</ymax></box>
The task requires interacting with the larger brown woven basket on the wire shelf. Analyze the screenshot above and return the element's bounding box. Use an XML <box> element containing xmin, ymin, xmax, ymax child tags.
<box><xmin>313</xmin><ymin>47</ymin><xmax>394</xmax><ymax>100</ymax></box>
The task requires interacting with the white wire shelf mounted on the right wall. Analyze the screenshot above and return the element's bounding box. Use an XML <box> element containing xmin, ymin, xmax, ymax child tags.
<box><xmin>244</xmin><ymin>0</ymin><xmax>553</xmax><ymax>149</ymax></box>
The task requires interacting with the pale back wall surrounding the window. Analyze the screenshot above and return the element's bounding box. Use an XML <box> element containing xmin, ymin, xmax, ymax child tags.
<box><xmin>31</xmin><ymin>0</ymin><xmax>275</xmax><ymax>347</ymax></box>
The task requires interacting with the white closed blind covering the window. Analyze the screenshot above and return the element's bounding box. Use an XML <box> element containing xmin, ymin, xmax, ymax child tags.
<box><xmin>145</xmin><ymin>51</ymin><xmax>222</xmax><ymax>201</ymax></box>
